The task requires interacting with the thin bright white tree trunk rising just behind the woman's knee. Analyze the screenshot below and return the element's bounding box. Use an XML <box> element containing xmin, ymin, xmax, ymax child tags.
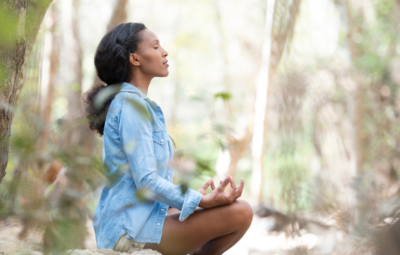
<box><xmin>251</xmin><ymin>0</ymin><xmax>301</xmax><ymax>203</ymax></box>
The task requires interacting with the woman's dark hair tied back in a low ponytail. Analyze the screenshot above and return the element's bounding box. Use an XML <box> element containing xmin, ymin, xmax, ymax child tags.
<box><xmin>83</xmin><ymin>23</ymin><xmax>146</xmax><ymax>136</ymax></box>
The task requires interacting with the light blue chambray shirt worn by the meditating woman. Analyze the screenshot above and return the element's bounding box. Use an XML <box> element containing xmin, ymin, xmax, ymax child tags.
<box><xmin>93</xmin><ymin>83</ymin><xmax>202</xmax><ymax>249</ymax></box>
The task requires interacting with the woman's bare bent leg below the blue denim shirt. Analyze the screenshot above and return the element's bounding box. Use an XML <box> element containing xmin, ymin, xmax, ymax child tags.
<box><xmin>145</xmin><ymin>200</ymin><xmax>253</xmax><ymax>255</ymax></box>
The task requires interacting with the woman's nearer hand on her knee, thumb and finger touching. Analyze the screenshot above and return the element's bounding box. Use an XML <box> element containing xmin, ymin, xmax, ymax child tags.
<box><xmin>199</xmin><ymin>176</ymin><xmax>244</xmax><ymax>208</ymax></box>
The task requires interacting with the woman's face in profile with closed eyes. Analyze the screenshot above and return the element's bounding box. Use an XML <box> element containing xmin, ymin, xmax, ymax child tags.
<box><xmin>130</xmin><ymin>29</ymin><xmax>169</xmax><ymax>77</ymax></box>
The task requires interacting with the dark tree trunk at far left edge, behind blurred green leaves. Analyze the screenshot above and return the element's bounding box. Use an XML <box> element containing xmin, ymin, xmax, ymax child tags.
<box><xmin>0</xmin><ymin>0</ymin><xmax>51</xmax><ymax>183</ymax></box>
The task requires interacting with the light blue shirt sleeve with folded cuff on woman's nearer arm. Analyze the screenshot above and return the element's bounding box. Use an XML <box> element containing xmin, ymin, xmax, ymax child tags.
<box><xmin>118</xmin><ymin>98</ymin><xmax>203</xmax><ymax>221</ymax></box>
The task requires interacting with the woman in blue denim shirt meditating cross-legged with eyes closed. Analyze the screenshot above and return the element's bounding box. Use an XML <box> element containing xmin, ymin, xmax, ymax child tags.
<box><xmin>85</xmin><ymin>23</ymin><xmax>253</xmax><ymax>255</ymax></box>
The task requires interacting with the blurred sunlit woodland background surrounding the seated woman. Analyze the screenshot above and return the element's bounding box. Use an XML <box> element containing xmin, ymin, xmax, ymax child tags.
<box><xmin>0</xmin><ymin>0</ymin><xmax>400</xmax><ymax>255</ymax></box>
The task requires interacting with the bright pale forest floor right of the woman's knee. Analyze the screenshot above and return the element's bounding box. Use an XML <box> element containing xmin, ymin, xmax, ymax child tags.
<box><xmin>224</xmin><ymin>216</ymin><xmax>374</xmax><ymax>255</ymax></box>
